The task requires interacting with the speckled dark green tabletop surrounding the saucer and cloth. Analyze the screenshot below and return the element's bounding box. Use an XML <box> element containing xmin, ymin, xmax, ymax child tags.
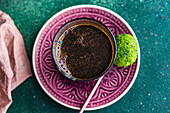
<box><xmin>0</xmin><ymin>0</ymin><xmax>170</xmax><ymax>113</ymax></box>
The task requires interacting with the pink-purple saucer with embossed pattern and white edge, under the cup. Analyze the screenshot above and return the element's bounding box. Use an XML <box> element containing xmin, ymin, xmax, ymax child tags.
<box><xmin>32</xmin><ymin>5</ymin><xmax>140</xmax><ymax>110</ymax></box>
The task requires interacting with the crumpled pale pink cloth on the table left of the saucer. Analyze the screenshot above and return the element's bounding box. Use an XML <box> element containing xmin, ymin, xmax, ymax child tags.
<box><xmin>0</xmin><ymin>10</ymin><xmax>32</xmax><ymax>113</ymax></box>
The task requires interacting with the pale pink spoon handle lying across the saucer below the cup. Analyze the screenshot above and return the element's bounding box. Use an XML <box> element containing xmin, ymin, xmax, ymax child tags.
<box><xmin>79</xmin><ymin>76</ymin><xmax>103</xmax><ymax>113</ymax></box>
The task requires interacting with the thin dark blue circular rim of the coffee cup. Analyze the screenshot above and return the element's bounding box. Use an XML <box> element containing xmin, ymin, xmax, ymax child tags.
<box><xmin>52</xmin><ymin>17</ymin><xmax>117</xmax><ymax>81</ymax></box>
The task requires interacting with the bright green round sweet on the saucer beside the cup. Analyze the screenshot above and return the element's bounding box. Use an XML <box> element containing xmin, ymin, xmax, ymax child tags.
<box><xmin>114</xmin><ymin>34</ymin><xmax>138</xmax><ymax>67</ymax></box>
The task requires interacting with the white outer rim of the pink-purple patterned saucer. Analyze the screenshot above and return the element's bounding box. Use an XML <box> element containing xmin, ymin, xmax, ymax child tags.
<box><xmin>32</xmin><ymin>5</ymin><xmax>140</xmax><ymax>111</ymax></box>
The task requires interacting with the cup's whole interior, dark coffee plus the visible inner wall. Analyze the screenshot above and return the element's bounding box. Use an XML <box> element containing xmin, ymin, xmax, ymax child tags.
<box><xmin>53</xmin><ymin>19</ymin><xmax>115</xmax><ymax>81</ymax></box>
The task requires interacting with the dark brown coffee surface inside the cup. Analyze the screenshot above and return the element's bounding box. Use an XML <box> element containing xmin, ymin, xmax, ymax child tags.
<box><xmin>61</xmin><ymin>25</ymin><xmax>112</xmax><ymax>79</ymax></box>
